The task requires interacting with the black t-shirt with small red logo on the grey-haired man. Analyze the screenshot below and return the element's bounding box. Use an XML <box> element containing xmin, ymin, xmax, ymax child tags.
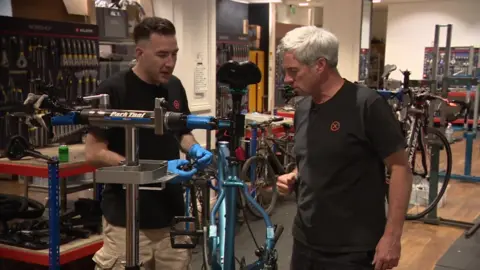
<box><xmin>293</xmin><ymin>81</ymin><xmax>405</xmax><ymax>252</ymax></box>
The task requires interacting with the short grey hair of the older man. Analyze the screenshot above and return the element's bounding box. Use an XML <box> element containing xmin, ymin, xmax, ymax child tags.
<box><xmin>277</xmin><ymin>26</ymin><xmax>338</xmax><ymax>68</ymax></box>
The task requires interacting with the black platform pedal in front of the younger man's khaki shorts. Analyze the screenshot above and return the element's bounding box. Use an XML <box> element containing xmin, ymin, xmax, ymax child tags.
<box><xmin>170</xmin><ymin>217</ymin><xmax>203</xmax><ymax>249</ymax></box>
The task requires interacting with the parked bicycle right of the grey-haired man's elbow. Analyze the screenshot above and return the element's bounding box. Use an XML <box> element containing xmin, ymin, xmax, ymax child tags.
<box><xmin>381</xmin><ymin>65</ymin><xmax>469</xmax><ymax>220</ymax></box>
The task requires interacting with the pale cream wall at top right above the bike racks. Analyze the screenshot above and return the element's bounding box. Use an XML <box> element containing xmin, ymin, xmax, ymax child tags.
<box><xmin>385</xmin><ymin>0</ymin><xmax>480</xmax><ymax>79</ymax></box>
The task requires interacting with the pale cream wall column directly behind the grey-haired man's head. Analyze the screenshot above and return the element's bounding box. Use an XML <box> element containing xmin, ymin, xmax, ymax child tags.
<box><xmin>323</xmin><ymin>0</ymin><xmax>362</xmax><ymax>81</ymax></box>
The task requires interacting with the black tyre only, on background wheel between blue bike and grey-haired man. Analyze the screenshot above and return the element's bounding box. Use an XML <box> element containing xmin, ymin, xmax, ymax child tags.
<box><xmin>241</xmin><ymin>156</ymin><xmax>278</xmax><ymax>218</ymax></box>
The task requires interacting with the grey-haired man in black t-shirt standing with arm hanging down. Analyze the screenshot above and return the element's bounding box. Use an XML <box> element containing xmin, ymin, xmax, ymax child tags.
<box><xmin>277</xmin><ymin>26</ymin><xmax>412</xmax><ymax>270</ymax></box>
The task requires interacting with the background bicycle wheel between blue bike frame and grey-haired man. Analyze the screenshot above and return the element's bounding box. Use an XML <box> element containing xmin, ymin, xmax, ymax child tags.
<box><xmin>241</xmin><ymin>155</ymin><xmax>278</xmax><ymax>218</ymax></box>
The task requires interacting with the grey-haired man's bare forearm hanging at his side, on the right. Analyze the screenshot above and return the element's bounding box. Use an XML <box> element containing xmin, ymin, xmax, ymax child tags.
<box><xmin>385</xmin><ymin>166</ymin><xmax>412</xmax><ymax>236</ymax></box>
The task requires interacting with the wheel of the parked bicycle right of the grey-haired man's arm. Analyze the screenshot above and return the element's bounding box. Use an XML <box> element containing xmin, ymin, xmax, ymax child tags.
<box><xmin>406</xmin><ymin>127</ymin><xmax>452</xmax><ymax>220</ymax></box>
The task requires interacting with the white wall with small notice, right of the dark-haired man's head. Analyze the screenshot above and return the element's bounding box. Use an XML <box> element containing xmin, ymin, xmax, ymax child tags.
<box><xmin>153</xmin><ymin>0</ymin><xmax>216</xmax><ymax>148</ymax></box>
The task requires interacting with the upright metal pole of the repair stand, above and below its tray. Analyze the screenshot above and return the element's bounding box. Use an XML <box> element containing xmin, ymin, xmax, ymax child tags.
<box><xmin>125</xmin><ymin>127</ymin><xmax>140</xmax><ymax>270</ymax></box>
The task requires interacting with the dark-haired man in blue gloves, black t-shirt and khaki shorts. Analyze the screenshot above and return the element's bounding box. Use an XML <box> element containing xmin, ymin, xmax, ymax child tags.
<box><xmin>85</xmin><ymin>18</ymin><xmax>212</xmax><ymax>270</ymax></box>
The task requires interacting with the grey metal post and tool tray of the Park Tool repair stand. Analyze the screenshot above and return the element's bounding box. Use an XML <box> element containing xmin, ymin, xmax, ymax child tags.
<box><xmin>92</xmin><ymin>96</ymin><xmax>176</xmax><ymax>270</ymax></box>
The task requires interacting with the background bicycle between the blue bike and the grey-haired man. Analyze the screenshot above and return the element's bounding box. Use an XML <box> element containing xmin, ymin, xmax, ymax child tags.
<box><xmin>240</xmin><ymin>117</ymin><xmax>295</xmax><ymax>218</ymax></box>
